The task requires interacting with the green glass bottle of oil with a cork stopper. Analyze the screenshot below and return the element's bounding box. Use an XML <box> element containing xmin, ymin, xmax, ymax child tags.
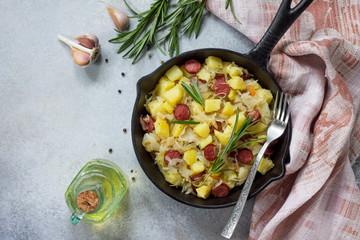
<box><xmin>65</xmin><ymin>159</ymin><xmax>128</xmax><ymax>225</ymax></box>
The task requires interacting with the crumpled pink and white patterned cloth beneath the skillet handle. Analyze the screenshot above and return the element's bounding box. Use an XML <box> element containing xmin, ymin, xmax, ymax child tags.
<box><xmin>207</xmin><ymin>0</ymin><xmax>360</xmax><ymax>240</ymax></box>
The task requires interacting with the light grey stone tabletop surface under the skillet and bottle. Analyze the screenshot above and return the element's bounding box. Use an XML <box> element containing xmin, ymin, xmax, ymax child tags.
<box><xmin>0</xmin><ymin>0</ymin><xmax>253</xmax><ymax>239</ymax></box>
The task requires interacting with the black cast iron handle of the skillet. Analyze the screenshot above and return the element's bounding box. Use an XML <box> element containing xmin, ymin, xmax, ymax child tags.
<box><xmin>248</xmin><ymin>0</ymin><xmax>313</xmax><ymax>70</ymax></box>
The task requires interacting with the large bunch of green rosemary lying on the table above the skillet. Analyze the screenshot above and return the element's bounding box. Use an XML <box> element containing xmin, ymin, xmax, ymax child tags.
<box><xmin>109</xmin><ymin>0</ymin><xmax>206</xmax><ymax>64</ymax></box>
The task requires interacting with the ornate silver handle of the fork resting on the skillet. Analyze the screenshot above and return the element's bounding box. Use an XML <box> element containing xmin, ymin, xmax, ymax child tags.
<box><xmin>221</xmin><ymin>141</ymin><xmax>271</xmax><ymax>239</ymax></box>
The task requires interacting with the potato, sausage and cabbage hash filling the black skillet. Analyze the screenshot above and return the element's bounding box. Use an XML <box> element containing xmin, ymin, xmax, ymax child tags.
<box><xmin>140</xmin><ymin>56</ymin><xmax>274</xmax><ymax>198</ymax></box>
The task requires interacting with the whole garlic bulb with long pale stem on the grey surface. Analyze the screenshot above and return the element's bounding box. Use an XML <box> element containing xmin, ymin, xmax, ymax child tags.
<box><xmin>57</xmin><ymin>34</ymin><xmax>101</xmax><ymax>67</ymax></box>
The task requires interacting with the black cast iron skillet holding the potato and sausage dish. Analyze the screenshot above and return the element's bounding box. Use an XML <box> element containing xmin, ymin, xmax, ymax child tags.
<box><xmin>131</xmin><ymin>0</ymin><xmax>313</xmax><ymax>208</ymax></box>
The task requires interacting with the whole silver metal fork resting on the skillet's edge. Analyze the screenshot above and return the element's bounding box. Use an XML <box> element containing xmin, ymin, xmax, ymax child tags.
<box><xmin>221</xmin><ymin>92</ymin><xmax>290</xmax><ymax>239</ymax></box>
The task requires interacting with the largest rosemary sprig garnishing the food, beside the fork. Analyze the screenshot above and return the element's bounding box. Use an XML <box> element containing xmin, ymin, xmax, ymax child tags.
<box><xmin>200</xmin><ymin>108</ymin><xmax>260</xmax><ymax>186</ymax></box>
